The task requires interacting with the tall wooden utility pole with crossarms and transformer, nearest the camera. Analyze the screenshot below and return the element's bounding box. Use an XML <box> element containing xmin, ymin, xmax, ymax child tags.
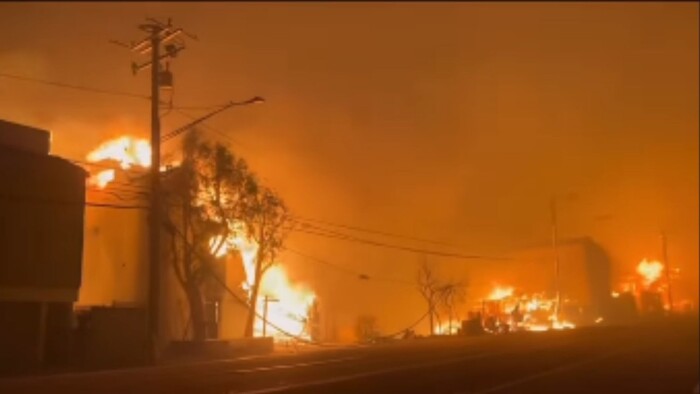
<box><xmin>117</xmin><ymin>18</ymin><xmax>190</xmax><ymax>362</ymax></box>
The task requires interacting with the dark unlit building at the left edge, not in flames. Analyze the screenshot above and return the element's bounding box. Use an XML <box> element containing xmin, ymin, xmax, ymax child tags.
<box><xmin>0</xmin><ymin>120</ymin><xmax>86</xmax><ymax>372</ymax></box>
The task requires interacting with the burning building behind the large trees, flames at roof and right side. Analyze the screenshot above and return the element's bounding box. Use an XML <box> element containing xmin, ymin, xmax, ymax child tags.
<box><xmin>78</xmin><ymin>136</ymin><xmax>315</xmax><ymax>339</ymax></box>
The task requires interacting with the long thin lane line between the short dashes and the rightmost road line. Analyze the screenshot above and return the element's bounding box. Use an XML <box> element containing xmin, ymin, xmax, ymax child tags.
<box><xmin>239</xmin><ymin>351</ymin><xmax>514</xmax><ymax>394</ymax></box>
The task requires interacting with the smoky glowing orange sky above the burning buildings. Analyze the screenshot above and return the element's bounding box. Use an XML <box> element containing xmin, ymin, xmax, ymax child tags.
<box><xmin>0</xmin><ymin>2</ymin><xmax>699</xmax><ymax>330</ymax></box>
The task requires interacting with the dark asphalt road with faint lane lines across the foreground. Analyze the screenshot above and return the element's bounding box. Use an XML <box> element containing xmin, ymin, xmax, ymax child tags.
<box><xmin>0</xmin><ymin>317</ymin><xmax>700</xmax><ymax>394</ymax></box>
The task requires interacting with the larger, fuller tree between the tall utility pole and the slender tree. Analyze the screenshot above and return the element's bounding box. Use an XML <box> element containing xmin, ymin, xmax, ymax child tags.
<box><xmin>163</xmin><ymin>132</ymin><xmax>257</xmax><ymax>341</ymax></box>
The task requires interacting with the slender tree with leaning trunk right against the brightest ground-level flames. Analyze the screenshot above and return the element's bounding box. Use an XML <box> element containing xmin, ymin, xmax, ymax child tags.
<box><xmin>244</xmin><ymin>187</ymin><xmax>290</xmax><ymax>338</ymax></box>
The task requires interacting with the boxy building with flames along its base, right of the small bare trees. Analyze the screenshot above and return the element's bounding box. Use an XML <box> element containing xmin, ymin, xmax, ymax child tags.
<box><xmin>472</xmin><ymin>238</ymin><xmax>611</xmax><ymax>330</ymax></box>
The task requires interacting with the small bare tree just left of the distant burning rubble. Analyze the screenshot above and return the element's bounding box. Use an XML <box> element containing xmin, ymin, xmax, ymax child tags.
<box><xmin>416</xmin><ymin>260</ymin><xmax>464</xmax><ymax>335</ymax></box>
